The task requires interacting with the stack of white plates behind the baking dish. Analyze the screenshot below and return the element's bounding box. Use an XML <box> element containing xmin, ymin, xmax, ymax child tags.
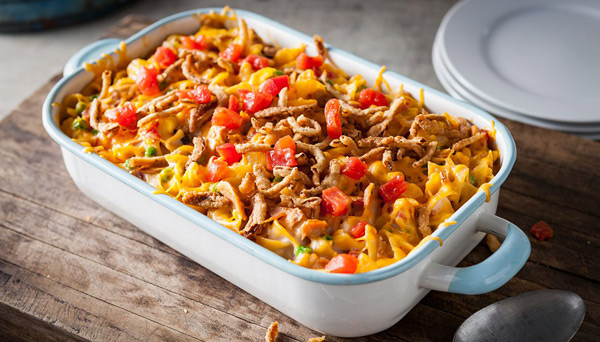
<box><xmin>433</xmin><ymin>0</ymin><xmax>600</xmax><ymax>139</ymax></box>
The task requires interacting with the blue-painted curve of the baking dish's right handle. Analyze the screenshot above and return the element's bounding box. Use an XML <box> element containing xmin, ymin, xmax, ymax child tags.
<box><xmin>448</xmin><ymin>222</ymin><xmax>531</xmax><ymax>295</ymax></box>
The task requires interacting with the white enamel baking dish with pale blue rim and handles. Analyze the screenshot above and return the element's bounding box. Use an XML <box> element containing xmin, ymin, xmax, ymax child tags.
<box><xmin>43</xmin><ymin>8</ymin><xmax>530</xmax><ymax>337</ymax></box>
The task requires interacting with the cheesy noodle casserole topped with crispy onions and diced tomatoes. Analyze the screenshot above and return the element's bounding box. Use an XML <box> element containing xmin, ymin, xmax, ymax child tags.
<box><xmin>59</xmin><ymin>8</ymin><xmax>499</xmax><ymax>273</ymax></box>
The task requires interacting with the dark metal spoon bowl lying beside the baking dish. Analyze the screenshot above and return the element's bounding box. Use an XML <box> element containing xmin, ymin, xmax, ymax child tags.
<box><xmin>454</xmin><ymin>290</ymin><xmax>585</xmax><ymax>342</ymax></box>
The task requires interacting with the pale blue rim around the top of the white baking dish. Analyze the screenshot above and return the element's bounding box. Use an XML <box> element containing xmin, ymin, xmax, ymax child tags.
<box><xmin>42</xmin><ymin>7</ymin><xmax>516</xmax><ymax>285</ymax></box>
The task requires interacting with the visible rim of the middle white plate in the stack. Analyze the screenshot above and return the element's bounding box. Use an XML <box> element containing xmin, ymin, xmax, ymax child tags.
<box><xmin>432</xmin><ymin>43</ymin><xmax>600</xmax><ymax>134</ymax></box>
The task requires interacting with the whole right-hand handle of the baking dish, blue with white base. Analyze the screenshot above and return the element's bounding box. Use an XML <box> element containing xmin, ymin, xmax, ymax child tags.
<box><xmin>420</xmin><ymin>213</ymin><xmax>531</xmax><ymax>294</ymax></box>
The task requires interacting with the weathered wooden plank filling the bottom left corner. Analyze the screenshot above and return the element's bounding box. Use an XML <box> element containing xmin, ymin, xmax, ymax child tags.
<box><xmin>0</xmin><ymin>259</ymin><xmax>193</xmax><ymax>341</ymax></box>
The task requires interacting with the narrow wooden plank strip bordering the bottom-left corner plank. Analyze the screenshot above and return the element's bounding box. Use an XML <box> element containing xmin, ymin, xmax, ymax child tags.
<box><xmin>0</xmin><ymin>225</ymin><xmax>295</xmax><ymax>341</ymax></box>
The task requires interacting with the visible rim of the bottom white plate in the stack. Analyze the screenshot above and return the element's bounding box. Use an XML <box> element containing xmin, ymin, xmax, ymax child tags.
<box><xmin>433</xmin><ymin>43</ymin><xmax>600</xmax><ymax>140</ymax></box>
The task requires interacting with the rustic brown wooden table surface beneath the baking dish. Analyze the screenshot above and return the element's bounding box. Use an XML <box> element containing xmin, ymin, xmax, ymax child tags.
<box><xmin>0</xmin><ymin>17</ymin><xmax>600</xmax><ymax>341</ymax></box>
